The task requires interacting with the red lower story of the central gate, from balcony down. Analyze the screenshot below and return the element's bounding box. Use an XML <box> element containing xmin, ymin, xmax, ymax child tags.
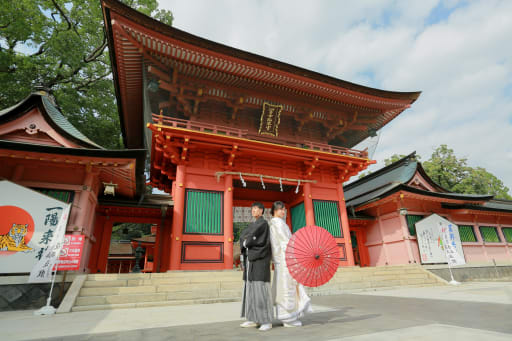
<box><xmin>148</xmin><ymin>117</ymin><xmax>370</xmax><ymax>270</ymax></box>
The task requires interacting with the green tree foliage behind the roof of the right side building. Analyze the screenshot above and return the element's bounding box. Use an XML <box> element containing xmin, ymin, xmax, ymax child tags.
<box><xmin>384</xmin><ymin>144</ymin><xmax>512</xmax><ymax>200</ymax></box>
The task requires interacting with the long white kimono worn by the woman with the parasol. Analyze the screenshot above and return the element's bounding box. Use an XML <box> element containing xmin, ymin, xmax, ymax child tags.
<box><xmin>270</xmin><ymin>217</ymin><xmax>312</xmax><ymax>323</ymax></box>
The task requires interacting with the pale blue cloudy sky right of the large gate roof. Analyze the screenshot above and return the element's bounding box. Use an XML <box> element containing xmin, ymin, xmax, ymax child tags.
<box><xmin>159</xmin><ymin>0</ymin><xmax>512</xmax><ymax>193</ymax></box>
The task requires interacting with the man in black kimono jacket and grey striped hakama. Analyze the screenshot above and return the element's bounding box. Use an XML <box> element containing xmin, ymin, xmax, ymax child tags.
<box><xmin>240</xmin><ymin>202</ymin><xmax>273</xmax><ymax>331</ymax></box>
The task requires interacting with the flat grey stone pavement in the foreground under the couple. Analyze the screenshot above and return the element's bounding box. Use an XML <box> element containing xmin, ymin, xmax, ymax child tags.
<box><xmin>0</xmin><ymin>282</ymin><xmax>512</xmax><ymax>341</ymax></box>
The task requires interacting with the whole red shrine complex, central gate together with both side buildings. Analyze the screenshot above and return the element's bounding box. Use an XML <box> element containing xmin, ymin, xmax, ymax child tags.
<box><xmin>0</xmin><ymin>0</ymin><xmax>512</xmax><ymax>274</ymax></box>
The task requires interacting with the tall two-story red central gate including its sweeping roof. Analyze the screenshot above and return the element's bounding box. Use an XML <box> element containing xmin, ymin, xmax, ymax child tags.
<box><xmin>94</xmin><ymin>0</ymin><xmax>420</xmax><ymax>272</ymax></box>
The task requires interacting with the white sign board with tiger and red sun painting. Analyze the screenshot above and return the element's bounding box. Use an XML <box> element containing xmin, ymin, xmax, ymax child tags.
<box><xmin>0</xmin><ymin>180</ymin><xmax>70</xmax><ymax>274</ymax></box>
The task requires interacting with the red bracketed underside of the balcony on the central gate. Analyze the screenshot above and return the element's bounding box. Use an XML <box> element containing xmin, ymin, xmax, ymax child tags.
<box><xmin>149</xmin><ymin>125</ymin><xmax>372</xmax><ymax>193</ymax></box>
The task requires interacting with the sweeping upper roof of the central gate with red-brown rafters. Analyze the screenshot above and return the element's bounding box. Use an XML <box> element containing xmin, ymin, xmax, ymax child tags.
<box><xmin>102</xmin><ymin>0</ymin><xmax>420</xmax><ymax>148</ymax></box>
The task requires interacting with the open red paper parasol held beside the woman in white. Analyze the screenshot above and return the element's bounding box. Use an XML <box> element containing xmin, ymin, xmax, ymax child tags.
<box><xmin>286</xmin><ymin>226</ymin><xmax>340</xmax><ymax>287</ymax></box>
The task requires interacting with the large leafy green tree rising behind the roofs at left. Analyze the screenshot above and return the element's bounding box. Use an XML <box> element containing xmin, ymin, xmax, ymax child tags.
<box><xmin>0</xmin><ymin>0</ymin><xmax>173</xmax><ymax>148</ymax></box>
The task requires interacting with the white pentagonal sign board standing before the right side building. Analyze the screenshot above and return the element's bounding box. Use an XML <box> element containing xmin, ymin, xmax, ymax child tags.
<box><xmin>416</xmin><ymin>214</ymin><xmax>465</xmax><ymax>265</ymax></box>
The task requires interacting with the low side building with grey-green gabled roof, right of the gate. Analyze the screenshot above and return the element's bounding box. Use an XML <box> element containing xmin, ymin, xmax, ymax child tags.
<box><xmin>344</xmin><ymin>153</ymin><xmax>512</xmax><ymax>266</ymax></box>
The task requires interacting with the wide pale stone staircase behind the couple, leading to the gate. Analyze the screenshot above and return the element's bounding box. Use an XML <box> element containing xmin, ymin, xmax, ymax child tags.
<box><xmin>72</xmin><ymin>265</ymin><xmax>446</xmax><ymax>311</ymax></box>
